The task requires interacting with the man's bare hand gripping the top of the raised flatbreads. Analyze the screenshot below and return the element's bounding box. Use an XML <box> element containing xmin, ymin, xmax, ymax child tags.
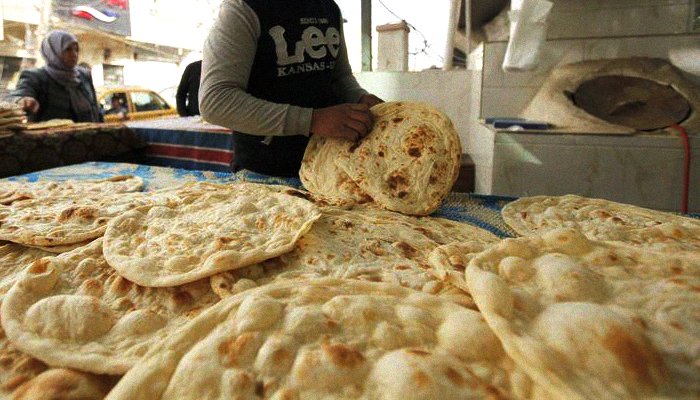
<box><xmin>311</xmin><ymin>104</ymin><xmax>372</xmax><ymax>141</ymax></box>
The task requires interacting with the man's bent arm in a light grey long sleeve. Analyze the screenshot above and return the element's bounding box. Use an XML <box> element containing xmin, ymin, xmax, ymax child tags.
<box><xmin>199</xmin><ymin>0</ymin><xmax>313</xmax><ymax>136</ymax></box>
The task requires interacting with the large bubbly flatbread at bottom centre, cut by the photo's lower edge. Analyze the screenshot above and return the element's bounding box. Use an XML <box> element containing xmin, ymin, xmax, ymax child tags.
<box><xmin>108</xmin><ymin>279</ymin><xmax>530</xmax><ymax>400</ymax></box>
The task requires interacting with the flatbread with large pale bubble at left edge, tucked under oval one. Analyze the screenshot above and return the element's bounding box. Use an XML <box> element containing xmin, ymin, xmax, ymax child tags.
<box><xmin>1</xmin><ymin>239</ymin><xmax>219</xmax><ymax>374</ymax></box>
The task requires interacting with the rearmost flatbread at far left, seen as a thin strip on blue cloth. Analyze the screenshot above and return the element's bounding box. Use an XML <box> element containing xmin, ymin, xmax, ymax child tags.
<box><xmin>0</xmin><ymin>175</ymin><xmax>143</xmax><ymax>205</ymax></box>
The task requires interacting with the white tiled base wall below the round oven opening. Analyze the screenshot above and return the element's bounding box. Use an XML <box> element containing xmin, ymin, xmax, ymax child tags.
<box><xmin>488</xmin><ymin>133</ymin><xmax>700</xmax><ymax>212</ymax></box>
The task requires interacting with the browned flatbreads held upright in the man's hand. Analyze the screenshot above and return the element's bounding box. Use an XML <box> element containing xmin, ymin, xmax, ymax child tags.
<box><xmin>299</xmin><ymin>102</ymin><xmax>462</xmax><ymax>215</ymax></box>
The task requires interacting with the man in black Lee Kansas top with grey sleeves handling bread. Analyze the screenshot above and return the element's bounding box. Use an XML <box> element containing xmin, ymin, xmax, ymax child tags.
<box><xmin>199</xmin><ymin>0</ymin><xmax>382</xmax><ymax>176</ymax></box>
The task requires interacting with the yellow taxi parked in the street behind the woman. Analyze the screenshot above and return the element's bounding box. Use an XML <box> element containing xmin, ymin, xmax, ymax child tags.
<box><xmin>97</xmin><ymin>86</ymin><xmax>177</xmax><ymax>122</ymax></box>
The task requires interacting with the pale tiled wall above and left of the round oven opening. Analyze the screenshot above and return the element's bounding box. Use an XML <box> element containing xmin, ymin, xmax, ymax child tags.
<box><xmin>480</xmin><ymin>0</ymin><xmax>700</xmax><ymax>117</ymax></box>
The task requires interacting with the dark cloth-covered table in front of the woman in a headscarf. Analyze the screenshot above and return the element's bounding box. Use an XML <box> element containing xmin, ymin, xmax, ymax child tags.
<box><xmin>0</xmin><ymin>123</ymin><xmax>146</xmax><ymax>178</ymax></box>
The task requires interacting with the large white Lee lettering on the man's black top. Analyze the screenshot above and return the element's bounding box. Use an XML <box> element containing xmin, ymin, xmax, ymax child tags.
<box><xmin>269</xmin><ymin>25</ymin><xmax>340</xmax><ymax>67</ymax></box>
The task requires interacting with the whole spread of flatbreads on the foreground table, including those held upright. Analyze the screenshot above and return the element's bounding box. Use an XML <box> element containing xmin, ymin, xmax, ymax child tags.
<box><xmin>0</xmin><ymin>104</ymin><xmax>700</xmax><ymax>399</ymax></box>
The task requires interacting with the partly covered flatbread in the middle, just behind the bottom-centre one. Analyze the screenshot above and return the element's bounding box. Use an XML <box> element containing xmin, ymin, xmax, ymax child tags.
<box><xmin>211</xmin><ymin>207</ymin><xmax>498</xmax><ymax>307</ymax></box>
